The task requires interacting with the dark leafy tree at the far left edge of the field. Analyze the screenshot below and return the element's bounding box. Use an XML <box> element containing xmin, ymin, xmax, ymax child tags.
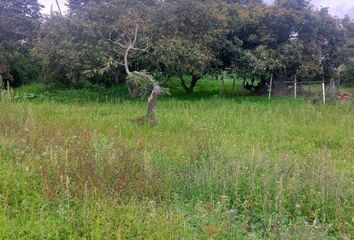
<box><xmin>0</xmin><ymin>0</ymin><xmax>43</xmax><ymax>84</ymax></box>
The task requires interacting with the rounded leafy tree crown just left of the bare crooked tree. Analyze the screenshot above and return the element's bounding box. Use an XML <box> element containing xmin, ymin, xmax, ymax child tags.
<box><xmin>36</xmin><ymin>16</ymin><xmax>113</xmax><ymax>87</ymax></box>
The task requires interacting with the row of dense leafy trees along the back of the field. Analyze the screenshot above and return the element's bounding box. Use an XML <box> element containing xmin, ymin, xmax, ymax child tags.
<box><xmin>0</xmin><ymin>0</ymin><xmax>354</xmax><ymax>94</ymax></box>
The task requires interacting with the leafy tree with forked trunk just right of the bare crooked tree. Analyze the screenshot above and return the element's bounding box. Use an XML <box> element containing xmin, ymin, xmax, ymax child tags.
<box><xmin>153</xmin><ymin>0</ymin><xmax>226</xmax><ymax>94</ymax></box>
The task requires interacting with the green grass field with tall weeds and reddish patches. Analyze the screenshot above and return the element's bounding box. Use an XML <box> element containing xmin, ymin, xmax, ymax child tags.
<box><xmin>0</xmin><ymin>81</ymin><xmax>354</xmax><ymax>239</ymax></box>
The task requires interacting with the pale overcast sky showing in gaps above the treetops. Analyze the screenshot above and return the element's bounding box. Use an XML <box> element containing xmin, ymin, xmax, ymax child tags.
<box><xmin>39</xmin><ymin>0</ymin><xmax>354</xmax><ymax>18</ymax></box>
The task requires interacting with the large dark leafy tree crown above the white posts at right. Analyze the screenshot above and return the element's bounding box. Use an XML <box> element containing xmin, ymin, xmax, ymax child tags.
<box><xmin>252</xmin><ymin>0</ymin><xmax>345</xmax><ymax>85</ymax></box>
